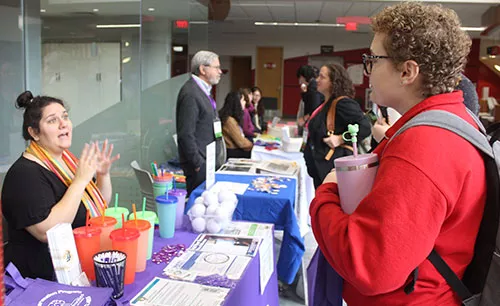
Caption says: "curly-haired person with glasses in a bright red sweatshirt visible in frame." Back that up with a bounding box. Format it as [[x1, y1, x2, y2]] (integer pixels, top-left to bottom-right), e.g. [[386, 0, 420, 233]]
[[310, 2, 486, 306]]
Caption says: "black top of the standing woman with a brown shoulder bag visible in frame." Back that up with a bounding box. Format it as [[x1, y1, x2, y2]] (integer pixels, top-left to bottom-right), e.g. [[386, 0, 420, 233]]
[[304, 98, 371, 187]]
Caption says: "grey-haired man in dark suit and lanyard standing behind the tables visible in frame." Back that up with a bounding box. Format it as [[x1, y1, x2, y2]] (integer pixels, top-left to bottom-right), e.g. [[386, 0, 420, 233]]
[[176, 51, 222, 194]]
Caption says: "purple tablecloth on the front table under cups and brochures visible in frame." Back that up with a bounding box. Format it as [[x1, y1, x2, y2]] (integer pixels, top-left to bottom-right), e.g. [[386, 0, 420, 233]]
[[117, 230, 279, 306]]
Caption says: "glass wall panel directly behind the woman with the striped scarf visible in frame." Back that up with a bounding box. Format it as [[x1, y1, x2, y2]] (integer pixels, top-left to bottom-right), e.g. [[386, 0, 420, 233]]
[[29, 0, 141, 207]]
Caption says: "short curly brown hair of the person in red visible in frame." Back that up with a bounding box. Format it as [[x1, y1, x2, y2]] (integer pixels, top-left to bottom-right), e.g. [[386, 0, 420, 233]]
[[372, 2, 472, 97]]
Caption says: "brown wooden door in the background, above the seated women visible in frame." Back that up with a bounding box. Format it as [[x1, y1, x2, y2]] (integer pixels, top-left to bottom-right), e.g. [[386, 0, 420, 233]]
[[255, 47, 283, 113]]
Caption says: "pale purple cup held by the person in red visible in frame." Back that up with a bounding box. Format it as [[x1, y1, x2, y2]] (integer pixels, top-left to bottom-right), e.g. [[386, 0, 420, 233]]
[[334, 153, 378, 215]]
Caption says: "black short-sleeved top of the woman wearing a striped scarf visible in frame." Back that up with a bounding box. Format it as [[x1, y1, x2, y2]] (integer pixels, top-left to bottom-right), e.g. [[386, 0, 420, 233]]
[[2, 156, 86, 280]]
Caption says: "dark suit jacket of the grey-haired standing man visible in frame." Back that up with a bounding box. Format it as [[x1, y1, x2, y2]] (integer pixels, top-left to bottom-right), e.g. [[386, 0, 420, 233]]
[[176, 77, 225, 175]]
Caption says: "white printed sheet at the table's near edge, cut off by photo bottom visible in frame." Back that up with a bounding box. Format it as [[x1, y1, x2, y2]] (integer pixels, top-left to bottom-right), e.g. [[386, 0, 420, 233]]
[[130, 277, 229, 306]]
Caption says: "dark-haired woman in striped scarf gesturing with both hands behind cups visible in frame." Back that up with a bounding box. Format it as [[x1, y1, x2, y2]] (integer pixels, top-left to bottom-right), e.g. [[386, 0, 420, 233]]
[[2, 91, 120, 280]]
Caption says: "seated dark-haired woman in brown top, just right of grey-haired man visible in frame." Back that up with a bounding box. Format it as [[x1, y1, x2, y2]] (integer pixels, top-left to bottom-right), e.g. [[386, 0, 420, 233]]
[[219, 92, 253, 158]]
